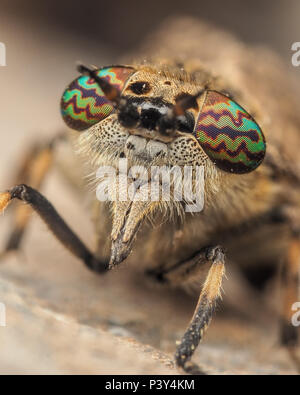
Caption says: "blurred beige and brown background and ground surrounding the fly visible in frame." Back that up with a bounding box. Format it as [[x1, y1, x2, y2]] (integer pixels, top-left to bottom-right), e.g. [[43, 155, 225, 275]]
[[0, 0, 300, 373]]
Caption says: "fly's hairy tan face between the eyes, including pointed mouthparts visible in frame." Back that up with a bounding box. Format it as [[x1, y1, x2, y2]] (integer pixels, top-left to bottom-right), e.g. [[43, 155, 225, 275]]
[[72, 67, 211, 265]]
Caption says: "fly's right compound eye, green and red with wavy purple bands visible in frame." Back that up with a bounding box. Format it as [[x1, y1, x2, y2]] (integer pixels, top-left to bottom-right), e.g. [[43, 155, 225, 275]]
[[194, 91, 266, 174]]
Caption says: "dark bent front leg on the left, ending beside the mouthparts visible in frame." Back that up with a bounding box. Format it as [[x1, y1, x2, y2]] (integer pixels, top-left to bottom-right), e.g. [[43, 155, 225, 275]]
[[0, 184, 108, 273]]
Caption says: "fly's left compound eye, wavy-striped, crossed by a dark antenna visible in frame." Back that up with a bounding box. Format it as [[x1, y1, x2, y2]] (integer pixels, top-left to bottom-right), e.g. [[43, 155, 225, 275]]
[[60, 66, 135, 131]]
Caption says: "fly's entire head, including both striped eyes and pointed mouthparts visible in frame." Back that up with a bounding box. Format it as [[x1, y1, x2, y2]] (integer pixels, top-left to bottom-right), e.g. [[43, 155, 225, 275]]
[[69, 66, 265, 265]]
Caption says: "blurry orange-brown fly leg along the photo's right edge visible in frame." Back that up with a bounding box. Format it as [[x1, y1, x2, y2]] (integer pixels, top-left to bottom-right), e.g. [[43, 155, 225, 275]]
[[280, 237, 300, 371]]
